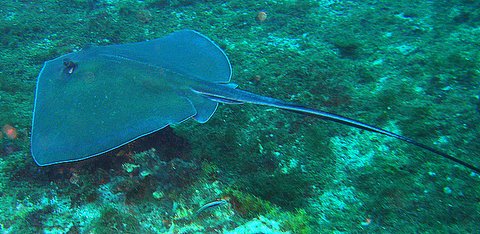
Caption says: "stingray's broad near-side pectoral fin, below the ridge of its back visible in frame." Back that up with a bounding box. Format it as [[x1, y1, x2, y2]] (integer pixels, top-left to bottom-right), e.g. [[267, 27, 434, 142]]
[[31, 51, 197, 166]]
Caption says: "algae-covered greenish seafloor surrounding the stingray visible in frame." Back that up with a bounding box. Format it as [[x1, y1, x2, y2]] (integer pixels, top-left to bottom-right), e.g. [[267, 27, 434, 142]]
[[0, 0, 480, 233]]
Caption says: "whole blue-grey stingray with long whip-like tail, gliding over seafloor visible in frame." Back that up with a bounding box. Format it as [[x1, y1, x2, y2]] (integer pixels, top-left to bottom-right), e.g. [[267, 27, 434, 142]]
[[31, 30, 480, 172]]
